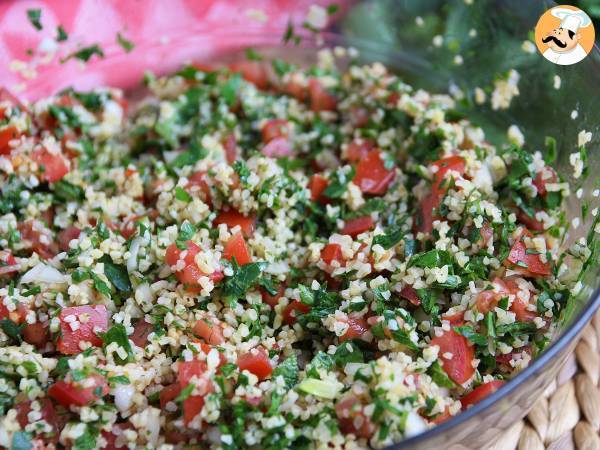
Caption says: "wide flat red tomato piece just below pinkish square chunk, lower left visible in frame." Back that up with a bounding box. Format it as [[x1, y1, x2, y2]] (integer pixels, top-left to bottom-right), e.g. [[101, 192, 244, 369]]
[[48, 374, 109, 408]]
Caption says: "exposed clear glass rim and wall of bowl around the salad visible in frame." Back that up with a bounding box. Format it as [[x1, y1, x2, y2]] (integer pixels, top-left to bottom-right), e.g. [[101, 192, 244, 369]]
[[5, 0, 600, 450]]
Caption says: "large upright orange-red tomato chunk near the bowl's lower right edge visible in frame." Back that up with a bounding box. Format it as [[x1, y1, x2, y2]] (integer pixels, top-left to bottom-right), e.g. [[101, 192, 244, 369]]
[[431, 330, 475, 384]]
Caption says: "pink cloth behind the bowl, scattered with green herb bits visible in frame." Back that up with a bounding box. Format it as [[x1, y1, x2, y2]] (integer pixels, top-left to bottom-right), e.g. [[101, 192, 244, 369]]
[[0, 0, 333, 100]]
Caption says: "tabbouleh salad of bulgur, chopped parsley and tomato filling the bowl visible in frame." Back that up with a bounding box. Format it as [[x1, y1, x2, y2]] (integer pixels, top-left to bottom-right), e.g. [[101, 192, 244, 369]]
[[0, 49, 591, 450]]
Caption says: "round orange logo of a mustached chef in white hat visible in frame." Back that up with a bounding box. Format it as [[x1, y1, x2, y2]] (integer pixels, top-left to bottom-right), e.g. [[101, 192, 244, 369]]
[[535, 5, 595, 66]]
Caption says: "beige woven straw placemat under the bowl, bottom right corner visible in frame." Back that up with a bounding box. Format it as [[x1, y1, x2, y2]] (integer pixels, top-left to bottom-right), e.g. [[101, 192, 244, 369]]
[[488, 312, 600, 450]]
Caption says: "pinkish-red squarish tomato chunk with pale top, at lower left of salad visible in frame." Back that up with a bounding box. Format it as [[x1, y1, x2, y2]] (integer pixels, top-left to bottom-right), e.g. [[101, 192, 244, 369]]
[[57, 305, 108, 355]]
